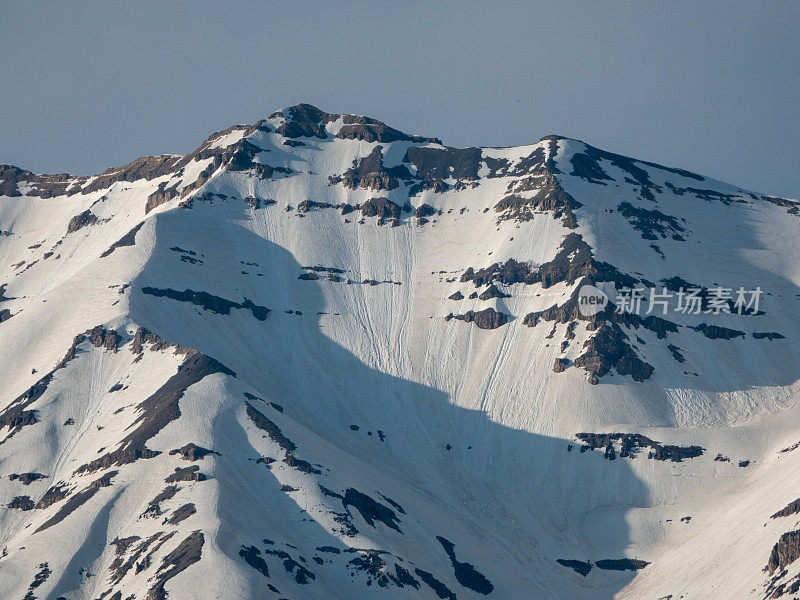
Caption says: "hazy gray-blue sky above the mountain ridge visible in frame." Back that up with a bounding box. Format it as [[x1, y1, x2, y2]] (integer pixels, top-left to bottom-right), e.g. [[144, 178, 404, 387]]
[[0, 0, 800, 197]]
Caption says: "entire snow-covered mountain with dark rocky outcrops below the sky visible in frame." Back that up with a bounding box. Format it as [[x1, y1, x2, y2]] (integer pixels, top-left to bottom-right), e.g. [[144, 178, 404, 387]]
[[0, 105, 800, 600]]
